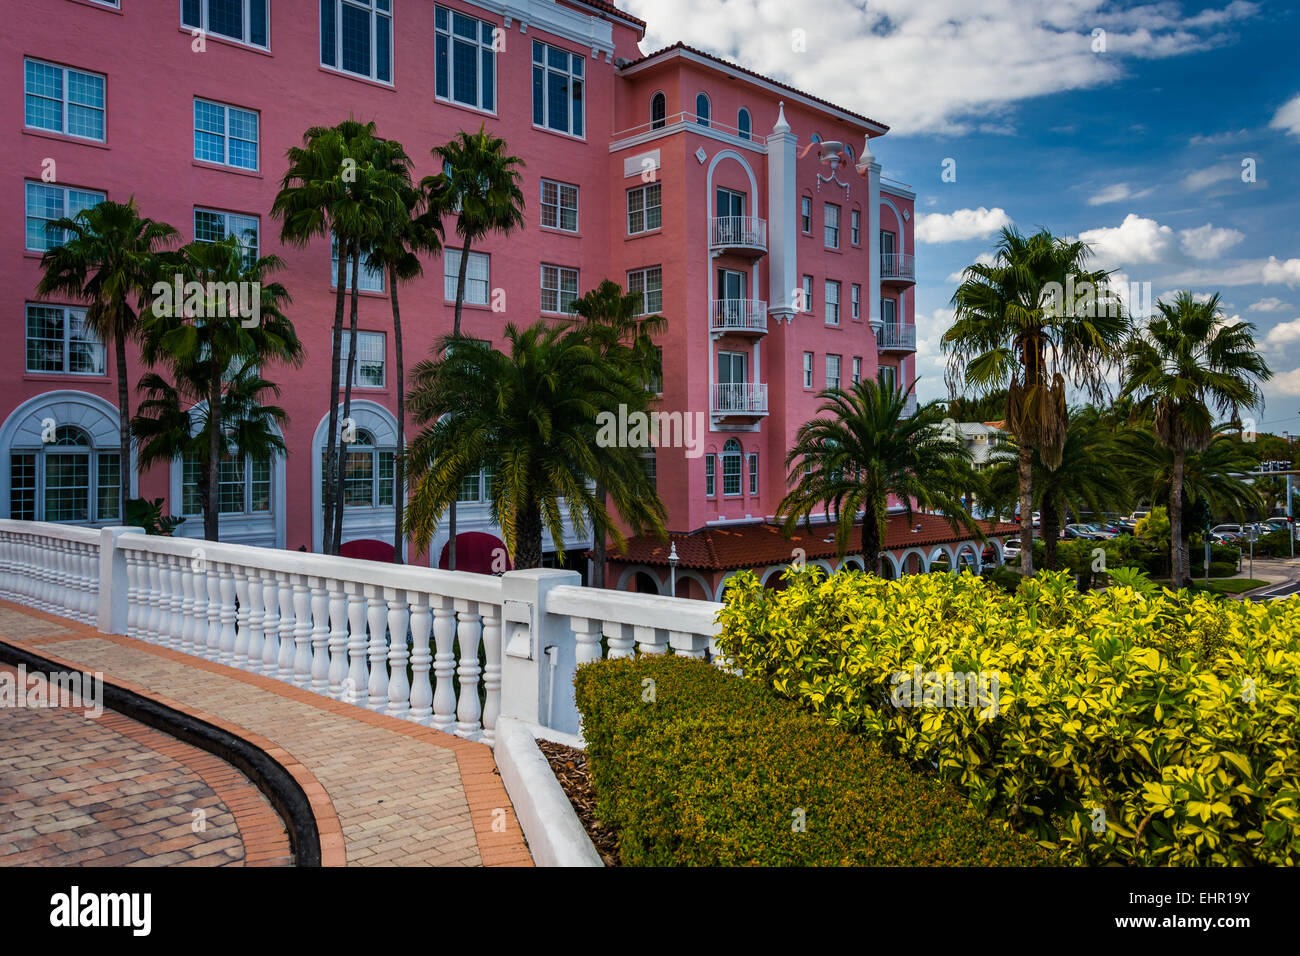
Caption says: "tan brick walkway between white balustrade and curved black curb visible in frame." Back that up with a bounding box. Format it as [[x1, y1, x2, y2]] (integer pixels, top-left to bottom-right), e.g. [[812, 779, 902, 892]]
[[0, 601, 532, 866]]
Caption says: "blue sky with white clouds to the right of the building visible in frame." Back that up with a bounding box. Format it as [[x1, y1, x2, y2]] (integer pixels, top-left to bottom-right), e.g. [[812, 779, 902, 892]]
[[619, 0, 1300, 434]]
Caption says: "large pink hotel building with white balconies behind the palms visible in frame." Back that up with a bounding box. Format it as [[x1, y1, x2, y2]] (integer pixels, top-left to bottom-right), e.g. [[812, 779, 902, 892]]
[[0, 0, 941, 597]]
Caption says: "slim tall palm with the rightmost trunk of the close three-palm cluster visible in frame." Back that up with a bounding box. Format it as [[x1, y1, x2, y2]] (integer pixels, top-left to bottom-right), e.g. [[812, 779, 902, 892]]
[[371, 140, 442, 563]]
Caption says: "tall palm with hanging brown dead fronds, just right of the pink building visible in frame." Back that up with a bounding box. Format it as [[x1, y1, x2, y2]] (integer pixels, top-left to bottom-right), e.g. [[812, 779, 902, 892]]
[[943, 226, 1127, 575]]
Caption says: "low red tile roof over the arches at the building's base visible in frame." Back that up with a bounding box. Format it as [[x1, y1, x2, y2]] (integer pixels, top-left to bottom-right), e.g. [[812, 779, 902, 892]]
[[610, 514, 1021, 571]]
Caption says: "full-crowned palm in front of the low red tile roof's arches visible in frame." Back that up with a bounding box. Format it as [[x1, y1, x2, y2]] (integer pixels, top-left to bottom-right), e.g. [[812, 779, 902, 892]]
[[777, 378, 983, 574]]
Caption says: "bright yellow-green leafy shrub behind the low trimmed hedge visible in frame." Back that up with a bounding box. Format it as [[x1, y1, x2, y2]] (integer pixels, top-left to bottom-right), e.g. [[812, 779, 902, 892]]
[[718, 568, 1300, 865]]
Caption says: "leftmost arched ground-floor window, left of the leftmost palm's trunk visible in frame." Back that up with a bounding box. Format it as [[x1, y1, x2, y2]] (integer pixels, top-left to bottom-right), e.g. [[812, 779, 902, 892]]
[[9, 425, 122, 524]]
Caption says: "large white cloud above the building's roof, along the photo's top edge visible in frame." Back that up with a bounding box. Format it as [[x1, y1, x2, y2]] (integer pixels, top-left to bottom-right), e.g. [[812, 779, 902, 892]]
[[620, 0, 1257, 138]]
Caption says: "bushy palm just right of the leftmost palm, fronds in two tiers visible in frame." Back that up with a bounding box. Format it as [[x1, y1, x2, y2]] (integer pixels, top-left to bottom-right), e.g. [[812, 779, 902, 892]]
[[133, 235, 303, 541]]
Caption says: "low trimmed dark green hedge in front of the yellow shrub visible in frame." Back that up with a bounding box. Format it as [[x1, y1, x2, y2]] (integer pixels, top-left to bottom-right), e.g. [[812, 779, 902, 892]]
[[575, 657, 1050, 866]]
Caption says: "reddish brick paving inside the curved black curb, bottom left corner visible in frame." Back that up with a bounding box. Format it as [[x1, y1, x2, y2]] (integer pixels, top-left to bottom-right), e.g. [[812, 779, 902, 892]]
[[0, 665, 293, 866]]
